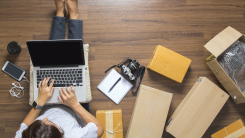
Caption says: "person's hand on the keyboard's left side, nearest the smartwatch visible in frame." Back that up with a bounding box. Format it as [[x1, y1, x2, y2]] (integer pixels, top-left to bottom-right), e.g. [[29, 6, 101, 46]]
[[37, 78, 54, 106]]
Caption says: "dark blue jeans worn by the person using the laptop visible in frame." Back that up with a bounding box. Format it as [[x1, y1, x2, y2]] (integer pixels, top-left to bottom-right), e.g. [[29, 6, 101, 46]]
[[50, 16, 90, 112]]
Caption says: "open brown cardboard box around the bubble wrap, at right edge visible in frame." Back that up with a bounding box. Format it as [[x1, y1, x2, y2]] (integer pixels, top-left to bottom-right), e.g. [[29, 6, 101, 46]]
[[204, 26, 245, 104]]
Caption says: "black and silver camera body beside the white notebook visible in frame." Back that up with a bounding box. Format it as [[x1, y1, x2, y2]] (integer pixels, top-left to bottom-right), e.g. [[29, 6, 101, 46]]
[[121, 60, 140, 81]]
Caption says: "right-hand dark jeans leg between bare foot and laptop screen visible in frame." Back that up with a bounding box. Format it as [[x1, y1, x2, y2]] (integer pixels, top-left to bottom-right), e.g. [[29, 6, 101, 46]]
[[68, 19, 83, 39]]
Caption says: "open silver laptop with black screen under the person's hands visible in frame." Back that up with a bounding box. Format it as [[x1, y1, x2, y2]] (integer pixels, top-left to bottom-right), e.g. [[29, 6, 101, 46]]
[[26, 39, 87, 103]]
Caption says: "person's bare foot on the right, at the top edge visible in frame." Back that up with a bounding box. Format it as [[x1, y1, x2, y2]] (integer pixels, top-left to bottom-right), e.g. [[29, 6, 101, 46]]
[[65, 0, 78, 19]]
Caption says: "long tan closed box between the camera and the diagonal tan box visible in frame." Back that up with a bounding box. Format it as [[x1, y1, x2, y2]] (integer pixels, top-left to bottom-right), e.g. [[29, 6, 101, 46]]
[[126, 84, 173, 138]]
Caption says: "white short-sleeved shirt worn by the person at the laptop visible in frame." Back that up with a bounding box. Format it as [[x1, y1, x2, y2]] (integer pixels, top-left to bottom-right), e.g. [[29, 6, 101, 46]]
[[15, 108, 98, 138]]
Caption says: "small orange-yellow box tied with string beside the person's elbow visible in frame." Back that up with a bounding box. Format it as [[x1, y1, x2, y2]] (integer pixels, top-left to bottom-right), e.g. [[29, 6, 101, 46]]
[[96, 109, 123, 138]]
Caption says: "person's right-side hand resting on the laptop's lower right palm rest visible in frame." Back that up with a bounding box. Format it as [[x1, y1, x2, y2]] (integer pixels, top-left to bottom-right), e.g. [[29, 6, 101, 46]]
[[58, 86, 80, 108]]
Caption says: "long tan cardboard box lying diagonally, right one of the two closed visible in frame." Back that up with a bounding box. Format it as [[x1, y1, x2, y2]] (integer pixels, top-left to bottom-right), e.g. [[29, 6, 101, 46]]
[[166, 77, 229, 138]]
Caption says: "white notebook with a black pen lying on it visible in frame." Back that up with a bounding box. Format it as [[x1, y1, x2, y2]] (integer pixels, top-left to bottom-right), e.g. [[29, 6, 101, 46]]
[[97, 69, 133, 104]]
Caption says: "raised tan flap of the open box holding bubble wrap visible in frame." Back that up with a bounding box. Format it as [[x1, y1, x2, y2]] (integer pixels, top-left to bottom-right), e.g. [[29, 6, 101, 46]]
[[204, 26, 242, 57]]
